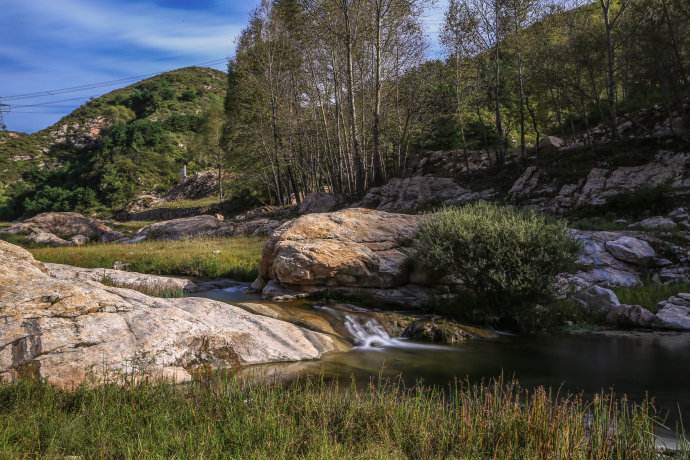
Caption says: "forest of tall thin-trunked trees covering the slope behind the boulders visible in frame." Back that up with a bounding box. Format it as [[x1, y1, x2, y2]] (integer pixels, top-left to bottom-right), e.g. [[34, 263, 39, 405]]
[[218, 0, 690, 204]]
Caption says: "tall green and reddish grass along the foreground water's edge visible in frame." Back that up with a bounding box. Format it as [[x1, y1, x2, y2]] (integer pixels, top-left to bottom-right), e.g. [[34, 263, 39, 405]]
[[0, 377, 685, 460]]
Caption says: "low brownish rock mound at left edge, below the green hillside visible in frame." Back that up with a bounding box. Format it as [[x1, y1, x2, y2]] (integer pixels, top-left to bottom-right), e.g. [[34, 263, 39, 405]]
[[4, 212, 122, 246]]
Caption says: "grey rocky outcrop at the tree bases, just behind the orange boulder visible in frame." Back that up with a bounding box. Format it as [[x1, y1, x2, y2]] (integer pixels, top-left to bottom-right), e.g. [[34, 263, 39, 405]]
[[358, 176, 495, 213]]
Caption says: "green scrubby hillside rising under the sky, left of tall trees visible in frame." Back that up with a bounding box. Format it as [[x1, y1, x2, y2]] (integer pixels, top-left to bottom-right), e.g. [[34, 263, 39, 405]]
[[0, 67, 225, 215]]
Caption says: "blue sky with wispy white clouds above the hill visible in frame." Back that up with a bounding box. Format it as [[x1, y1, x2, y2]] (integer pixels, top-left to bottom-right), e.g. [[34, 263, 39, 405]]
[[0, 0, 445, 132]]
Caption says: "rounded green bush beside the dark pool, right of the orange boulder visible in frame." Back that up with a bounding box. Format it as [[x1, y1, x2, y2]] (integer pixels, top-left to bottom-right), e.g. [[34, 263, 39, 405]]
[[415, 203, 577, 324]]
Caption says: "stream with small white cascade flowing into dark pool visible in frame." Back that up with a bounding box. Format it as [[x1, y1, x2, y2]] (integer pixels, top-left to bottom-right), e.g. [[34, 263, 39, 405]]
[[198, 287, 690, 442]]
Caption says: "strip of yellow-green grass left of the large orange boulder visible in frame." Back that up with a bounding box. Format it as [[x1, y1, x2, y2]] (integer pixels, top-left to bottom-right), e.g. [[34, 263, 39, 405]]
[[30, 238, 263, 281]]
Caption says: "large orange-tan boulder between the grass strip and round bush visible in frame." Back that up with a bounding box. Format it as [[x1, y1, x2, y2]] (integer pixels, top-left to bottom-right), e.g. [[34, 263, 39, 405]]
[[255, 209, 432, 305]]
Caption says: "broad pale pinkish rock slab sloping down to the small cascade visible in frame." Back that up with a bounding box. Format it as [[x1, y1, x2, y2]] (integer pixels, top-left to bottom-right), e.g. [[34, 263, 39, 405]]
[[0, 241, 344, 388]]
